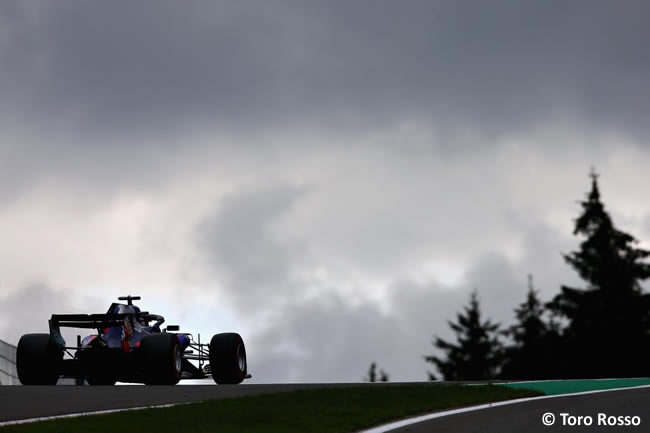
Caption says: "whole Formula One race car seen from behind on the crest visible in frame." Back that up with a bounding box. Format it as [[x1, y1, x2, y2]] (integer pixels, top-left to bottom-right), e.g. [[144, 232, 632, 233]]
[[16, 295, 251, 385]]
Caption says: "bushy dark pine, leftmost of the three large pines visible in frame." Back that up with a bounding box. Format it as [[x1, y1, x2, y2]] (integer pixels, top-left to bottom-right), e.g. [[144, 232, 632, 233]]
[[424, 291, 501, 380]]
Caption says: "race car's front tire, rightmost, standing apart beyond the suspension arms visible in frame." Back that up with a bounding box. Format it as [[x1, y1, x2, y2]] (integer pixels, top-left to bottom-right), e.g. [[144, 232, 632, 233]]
[[210, 332, 248, 385]]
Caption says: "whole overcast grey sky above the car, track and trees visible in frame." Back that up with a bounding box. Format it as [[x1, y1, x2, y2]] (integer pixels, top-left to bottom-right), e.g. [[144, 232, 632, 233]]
[[0, 0, 650, 382]]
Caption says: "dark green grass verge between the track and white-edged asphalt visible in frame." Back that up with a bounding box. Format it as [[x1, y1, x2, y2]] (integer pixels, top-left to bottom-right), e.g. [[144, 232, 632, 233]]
[[0, 384, 541, 433]]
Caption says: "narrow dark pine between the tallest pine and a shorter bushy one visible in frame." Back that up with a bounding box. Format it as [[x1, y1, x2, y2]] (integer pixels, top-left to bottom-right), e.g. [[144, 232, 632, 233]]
[[500, 275, 556, 379]]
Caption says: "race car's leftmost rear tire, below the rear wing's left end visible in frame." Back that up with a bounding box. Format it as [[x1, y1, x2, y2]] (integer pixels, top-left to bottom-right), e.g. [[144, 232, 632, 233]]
[[16, 334, 63, 385]]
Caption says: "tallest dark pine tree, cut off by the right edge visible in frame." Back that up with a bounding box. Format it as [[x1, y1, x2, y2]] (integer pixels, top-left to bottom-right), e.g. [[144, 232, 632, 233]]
[[549, 170, 650, 377]]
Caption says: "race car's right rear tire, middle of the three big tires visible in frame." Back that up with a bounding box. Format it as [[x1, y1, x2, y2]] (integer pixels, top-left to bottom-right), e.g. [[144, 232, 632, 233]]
[[140, 333, 183, 385]]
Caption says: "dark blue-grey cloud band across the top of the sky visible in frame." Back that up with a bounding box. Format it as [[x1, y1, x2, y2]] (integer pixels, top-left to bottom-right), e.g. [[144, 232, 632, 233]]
[[5, 1, 650, 135]]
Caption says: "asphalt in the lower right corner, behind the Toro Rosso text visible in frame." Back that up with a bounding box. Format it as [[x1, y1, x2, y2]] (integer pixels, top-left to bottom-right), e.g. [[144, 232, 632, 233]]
[[391, 388, 650, 433]]
